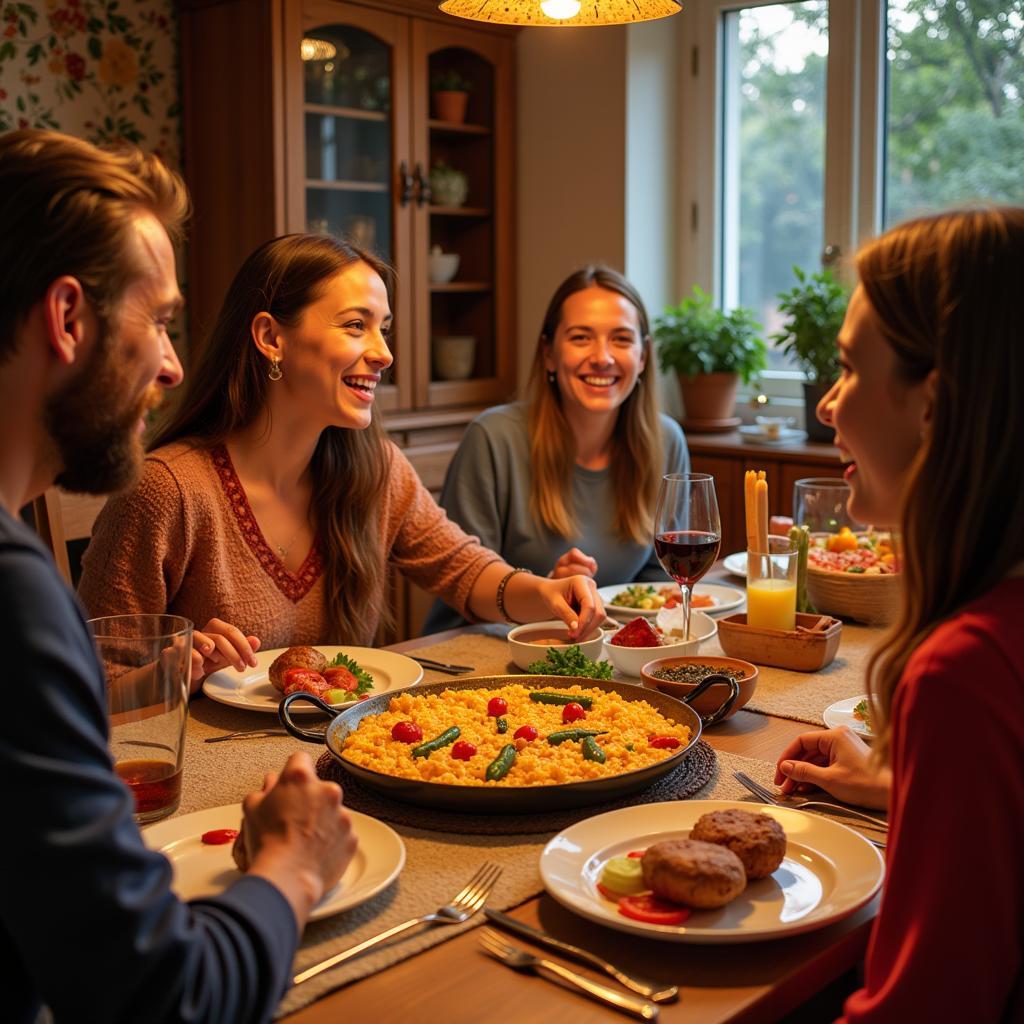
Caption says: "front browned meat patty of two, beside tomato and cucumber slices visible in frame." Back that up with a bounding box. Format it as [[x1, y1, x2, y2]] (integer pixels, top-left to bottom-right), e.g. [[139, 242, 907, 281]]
[[640, 839, 746, 910]]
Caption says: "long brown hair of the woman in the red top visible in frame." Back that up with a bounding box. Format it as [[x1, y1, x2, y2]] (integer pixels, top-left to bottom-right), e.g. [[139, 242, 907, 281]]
[[857, 207, 1024, 760]]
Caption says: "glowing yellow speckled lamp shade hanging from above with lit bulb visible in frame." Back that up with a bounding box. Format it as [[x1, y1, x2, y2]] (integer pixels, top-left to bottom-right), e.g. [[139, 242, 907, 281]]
[[440, 0, 680, 28]]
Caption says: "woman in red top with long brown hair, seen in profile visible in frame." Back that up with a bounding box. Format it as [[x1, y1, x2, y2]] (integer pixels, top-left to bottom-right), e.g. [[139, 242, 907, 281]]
[[775, 208, 1024, 1024]]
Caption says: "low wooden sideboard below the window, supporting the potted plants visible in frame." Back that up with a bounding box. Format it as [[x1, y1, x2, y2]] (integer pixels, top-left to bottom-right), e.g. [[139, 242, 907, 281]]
[[686, 433, 843, 555]]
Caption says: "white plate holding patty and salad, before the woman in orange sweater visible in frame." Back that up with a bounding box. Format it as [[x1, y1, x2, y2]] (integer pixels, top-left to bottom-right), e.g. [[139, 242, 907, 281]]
[[203, 644, 423, 715]]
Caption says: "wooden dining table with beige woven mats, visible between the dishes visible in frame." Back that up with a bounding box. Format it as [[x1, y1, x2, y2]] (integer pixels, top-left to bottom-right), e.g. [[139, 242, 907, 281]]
[[167, 568, 881, 1024]]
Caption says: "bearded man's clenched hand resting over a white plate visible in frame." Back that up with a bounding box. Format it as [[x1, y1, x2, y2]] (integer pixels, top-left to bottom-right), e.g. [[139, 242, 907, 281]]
[[242, 753, 358, 930]]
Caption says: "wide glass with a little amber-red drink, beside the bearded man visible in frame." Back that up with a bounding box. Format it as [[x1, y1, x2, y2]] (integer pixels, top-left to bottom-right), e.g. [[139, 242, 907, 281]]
[[89, 614, 193, 823]]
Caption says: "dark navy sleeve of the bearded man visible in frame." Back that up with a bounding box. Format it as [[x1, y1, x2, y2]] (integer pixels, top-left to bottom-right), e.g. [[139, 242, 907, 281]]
[[0, 511, 297, 1024]]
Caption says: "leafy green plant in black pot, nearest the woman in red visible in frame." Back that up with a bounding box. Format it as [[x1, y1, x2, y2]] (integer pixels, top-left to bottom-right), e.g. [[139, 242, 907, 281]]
[[771, 266, 850, 441]]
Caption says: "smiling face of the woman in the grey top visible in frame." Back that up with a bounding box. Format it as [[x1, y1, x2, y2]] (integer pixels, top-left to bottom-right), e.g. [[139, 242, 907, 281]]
[[544, 287, 647, 415]]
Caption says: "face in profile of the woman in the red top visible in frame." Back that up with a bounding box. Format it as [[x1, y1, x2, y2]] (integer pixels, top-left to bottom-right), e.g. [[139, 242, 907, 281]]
[[817, 287, 931, 526]]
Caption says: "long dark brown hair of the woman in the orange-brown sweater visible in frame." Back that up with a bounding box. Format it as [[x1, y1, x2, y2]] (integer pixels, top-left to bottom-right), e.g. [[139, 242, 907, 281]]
[[151, 234, 393, 642]]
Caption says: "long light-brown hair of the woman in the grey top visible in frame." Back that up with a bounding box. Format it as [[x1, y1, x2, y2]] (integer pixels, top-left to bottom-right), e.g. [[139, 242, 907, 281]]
[[527, 265, 665, 544]]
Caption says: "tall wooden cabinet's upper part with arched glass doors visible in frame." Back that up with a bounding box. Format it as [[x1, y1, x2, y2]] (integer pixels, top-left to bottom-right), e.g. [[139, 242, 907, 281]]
[[181, 0, 515, 414]]
